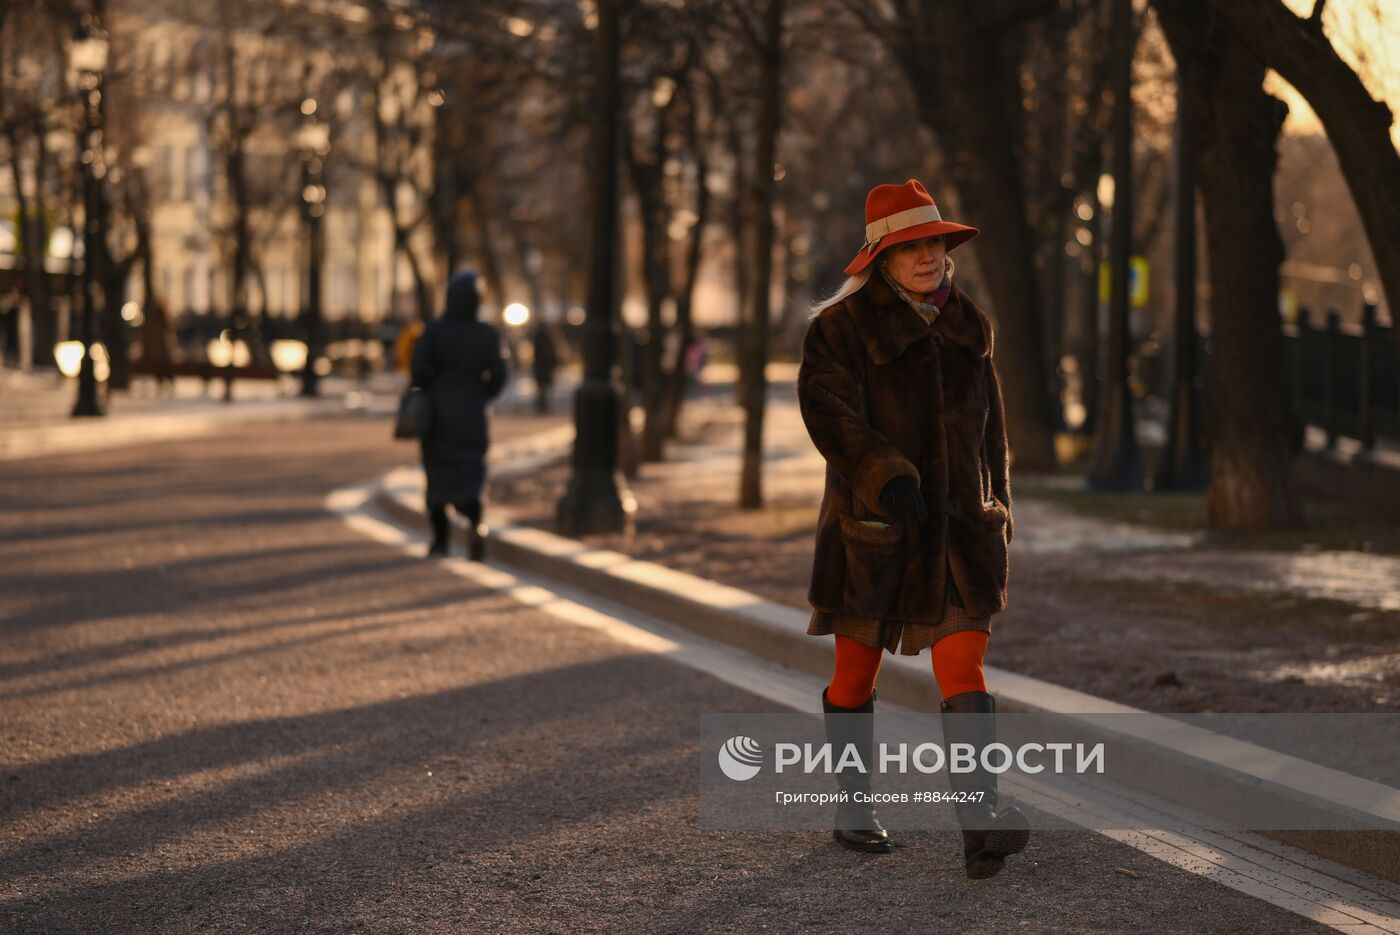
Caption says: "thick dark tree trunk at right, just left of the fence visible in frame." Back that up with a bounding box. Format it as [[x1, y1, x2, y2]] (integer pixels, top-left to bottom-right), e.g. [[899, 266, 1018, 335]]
[[1156, 0, 1302, 529]]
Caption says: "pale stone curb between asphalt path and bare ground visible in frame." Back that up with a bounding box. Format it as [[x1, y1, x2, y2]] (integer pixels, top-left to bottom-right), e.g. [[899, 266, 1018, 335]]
[[374, 470, 1400, 882]]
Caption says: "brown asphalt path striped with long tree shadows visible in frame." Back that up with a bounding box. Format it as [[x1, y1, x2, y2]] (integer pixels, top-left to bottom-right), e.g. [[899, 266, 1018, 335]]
[[0, 417, 1324, 932]]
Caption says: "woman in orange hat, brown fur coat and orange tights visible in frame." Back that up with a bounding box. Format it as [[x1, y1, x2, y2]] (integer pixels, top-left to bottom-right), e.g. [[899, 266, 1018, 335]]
[[798, 179, 1029, 879]]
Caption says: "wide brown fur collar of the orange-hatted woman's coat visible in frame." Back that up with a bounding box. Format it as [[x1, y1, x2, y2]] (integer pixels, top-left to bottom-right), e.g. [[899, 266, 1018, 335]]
[[846, 276, 993, 364]]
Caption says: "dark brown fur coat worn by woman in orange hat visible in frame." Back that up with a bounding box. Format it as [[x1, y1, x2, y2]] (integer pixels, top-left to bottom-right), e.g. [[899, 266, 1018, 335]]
[[798, 276, 1014, 623]]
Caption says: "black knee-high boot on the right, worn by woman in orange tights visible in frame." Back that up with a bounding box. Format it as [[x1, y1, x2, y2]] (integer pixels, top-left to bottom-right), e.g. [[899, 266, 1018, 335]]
[[942, 691, 1030, 880]]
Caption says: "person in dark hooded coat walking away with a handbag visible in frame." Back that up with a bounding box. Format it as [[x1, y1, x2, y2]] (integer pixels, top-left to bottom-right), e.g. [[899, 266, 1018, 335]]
[[413, 273, 507, 561]]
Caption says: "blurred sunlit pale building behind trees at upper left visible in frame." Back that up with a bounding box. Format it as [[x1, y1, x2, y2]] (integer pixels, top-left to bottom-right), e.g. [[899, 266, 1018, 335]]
[[0, 0, 441, 361]]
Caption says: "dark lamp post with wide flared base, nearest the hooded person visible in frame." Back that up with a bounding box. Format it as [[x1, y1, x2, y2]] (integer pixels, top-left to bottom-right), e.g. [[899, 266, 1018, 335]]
[[556, 0, 636, 536]]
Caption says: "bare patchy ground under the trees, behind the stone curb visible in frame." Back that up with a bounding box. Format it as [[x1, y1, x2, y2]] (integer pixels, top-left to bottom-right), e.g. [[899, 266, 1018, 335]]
[[493, 406, 1400, 712]]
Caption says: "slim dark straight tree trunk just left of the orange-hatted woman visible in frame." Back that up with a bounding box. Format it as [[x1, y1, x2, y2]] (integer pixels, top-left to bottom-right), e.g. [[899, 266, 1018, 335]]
[[739, 0, 783, 509]]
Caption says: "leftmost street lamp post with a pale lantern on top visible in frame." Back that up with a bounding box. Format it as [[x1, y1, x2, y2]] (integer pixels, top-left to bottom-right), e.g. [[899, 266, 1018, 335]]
[[70, 18, 108, 417]]
